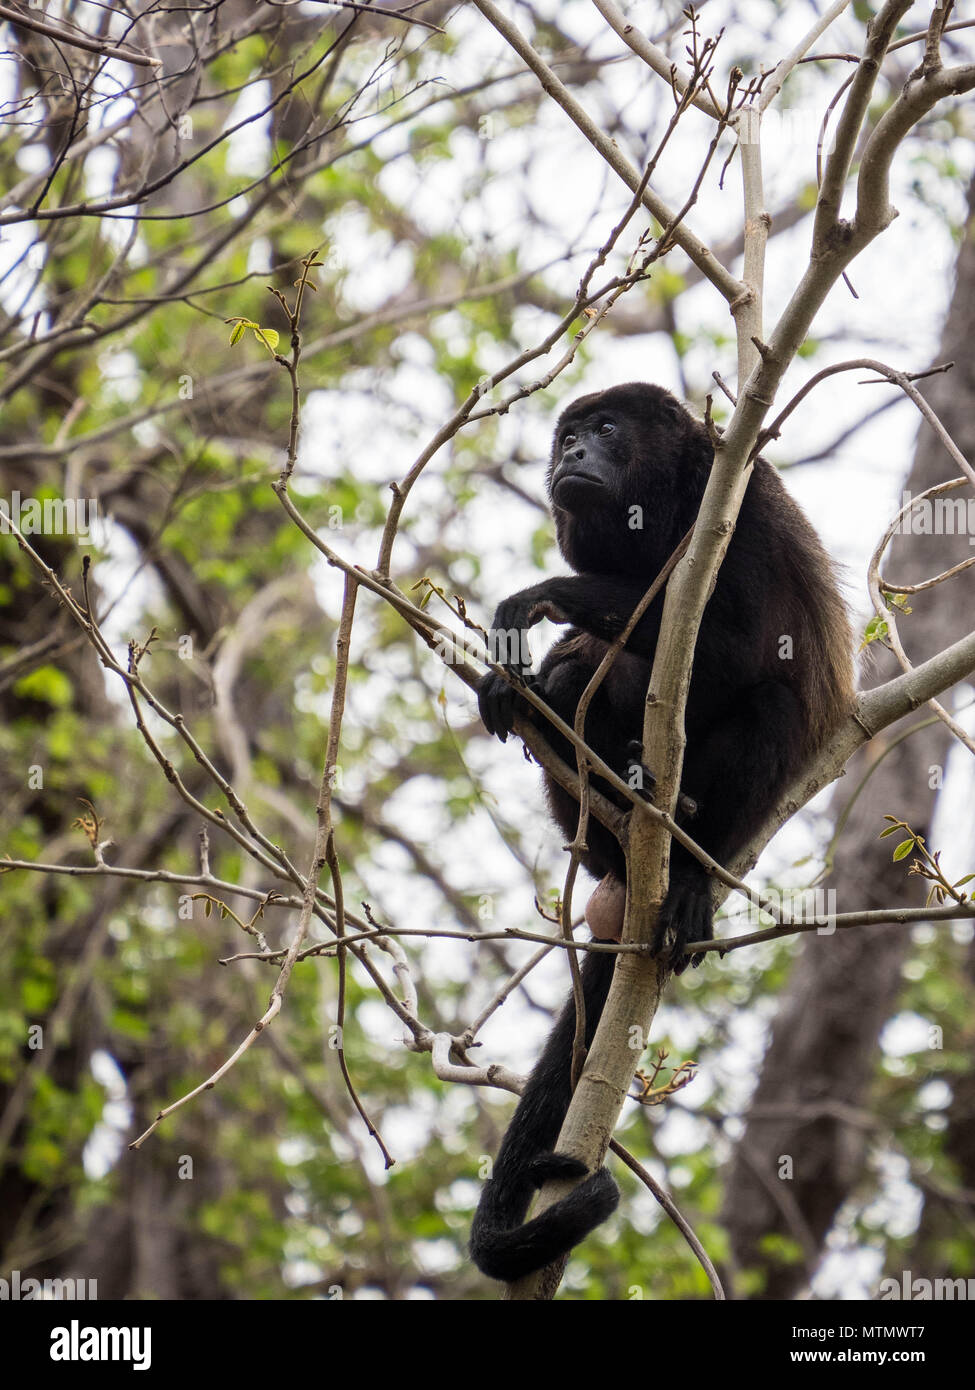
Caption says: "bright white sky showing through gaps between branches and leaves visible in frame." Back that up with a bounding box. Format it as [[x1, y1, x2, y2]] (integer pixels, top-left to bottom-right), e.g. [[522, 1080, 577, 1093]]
[[7, 0, 975, 1297]]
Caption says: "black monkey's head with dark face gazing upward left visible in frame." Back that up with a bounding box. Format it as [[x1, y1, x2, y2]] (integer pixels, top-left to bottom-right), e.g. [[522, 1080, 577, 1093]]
[[548, 382, 712, 574]]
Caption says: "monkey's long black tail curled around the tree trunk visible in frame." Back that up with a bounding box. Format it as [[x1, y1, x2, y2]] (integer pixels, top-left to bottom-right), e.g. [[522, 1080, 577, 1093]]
[[470, 952, 619, 1283]]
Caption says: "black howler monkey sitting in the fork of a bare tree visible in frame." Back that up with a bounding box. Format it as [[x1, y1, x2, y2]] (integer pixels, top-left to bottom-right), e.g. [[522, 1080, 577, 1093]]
[[470, 382, 853, 1280]]
